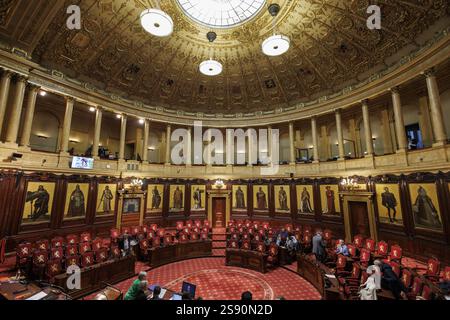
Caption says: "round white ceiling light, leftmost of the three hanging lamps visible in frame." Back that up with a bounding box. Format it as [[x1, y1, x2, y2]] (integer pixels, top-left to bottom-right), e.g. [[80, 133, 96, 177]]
[[141, 9, 173, 37]]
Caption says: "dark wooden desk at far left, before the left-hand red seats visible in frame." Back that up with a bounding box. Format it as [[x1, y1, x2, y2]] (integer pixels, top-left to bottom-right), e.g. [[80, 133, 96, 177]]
[[54, 255, 136, 299]]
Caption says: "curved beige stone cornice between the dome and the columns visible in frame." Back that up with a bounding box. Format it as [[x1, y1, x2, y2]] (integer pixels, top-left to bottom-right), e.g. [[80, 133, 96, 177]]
[[0, 30, 450, 127]]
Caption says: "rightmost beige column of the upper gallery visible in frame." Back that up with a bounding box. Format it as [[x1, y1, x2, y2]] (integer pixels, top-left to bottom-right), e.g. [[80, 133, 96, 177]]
[[425, 69, 447, 145]]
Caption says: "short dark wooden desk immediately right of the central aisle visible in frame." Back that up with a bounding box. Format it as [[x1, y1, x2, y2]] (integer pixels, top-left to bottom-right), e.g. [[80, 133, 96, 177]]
[[225, 248, 267, 273]]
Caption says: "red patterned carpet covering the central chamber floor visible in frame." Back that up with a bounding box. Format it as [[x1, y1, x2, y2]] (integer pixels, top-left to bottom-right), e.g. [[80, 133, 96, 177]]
[[86, 258, 321, 300]]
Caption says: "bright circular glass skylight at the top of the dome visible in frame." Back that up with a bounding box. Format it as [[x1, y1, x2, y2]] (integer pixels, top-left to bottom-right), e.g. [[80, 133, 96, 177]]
[[177, 0, 266, 28]]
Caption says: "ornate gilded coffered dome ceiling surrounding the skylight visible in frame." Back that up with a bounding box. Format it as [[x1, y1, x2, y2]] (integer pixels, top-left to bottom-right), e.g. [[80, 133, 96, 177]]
[[33, 0, 450, 114]]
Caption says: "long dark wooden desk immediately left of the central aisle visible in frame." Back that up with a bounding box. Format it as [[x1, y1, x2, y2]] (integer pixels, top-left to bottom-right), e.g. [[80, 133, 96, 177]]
[[148, 240, 212, 268]]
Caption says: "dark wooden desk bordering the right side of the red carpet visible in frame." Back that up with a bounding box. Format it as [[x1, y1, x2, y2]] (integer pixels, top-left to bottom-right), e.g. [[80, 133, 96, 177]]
[[297, 254, 341, 300]]
